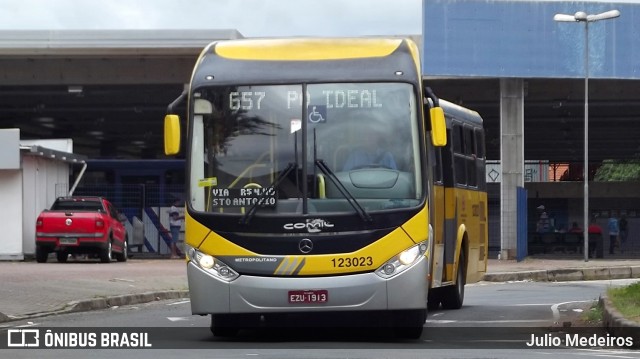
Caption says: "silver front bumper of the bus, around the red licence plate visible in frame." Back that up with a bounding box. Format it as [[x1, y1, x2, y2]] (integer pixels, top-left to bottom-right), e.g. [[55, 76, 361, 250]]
[[187, 257, 429, 315]]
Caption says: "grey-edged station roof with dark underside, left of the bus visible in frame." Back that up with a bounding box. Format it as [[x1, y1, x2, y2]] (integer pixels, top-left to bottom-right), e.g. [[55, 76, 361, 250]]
[[0, 30, 242, 158]]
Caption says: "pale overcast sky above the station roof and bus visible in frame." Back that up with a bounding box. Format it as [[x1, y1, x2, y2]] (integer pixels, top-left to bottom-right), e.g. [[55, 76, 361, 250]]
[[0, 0, 422, 37]]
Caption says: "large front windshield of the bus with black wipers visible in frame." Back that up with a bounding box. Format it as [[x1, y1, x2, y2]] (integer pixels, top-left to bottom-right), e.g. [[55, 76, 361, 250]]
[[190, 82, 425, 214]]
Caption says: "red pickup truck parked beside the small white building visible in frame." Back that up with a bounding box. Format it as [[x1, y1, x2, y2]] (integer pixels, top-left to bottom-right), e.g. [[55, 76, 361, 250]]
[[36, 197, 127, 263]]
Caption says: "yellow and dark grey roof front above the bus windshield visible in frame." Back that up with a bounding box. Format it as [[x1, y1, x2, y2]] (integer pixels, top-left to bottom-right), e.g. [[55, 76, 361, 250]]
[[191, 38, 420, 89]]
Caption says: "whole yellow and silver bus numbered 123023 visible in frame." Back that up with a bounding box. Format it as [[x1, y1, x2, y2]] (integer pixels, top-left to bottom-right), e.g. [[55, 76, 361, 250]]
[[164, 38, 487, 338]]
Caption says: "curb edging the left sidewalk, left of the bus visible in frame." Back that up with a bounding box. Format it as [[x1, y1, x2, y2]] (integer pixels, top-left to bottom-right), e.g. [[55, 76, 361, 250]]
[[0, 290, 189, 323]]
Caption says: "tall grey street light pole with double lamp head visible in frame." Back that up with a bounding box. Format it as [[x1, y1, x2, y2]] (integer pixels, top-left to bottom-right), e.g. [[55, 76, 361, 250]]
[[553, 10, 620, 262]]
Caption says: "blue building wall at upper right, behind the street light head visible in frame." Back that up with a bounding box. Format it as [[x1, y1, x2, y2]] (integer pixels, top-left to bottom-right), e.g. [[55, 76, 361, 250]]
[[422, 0, 640, 79]]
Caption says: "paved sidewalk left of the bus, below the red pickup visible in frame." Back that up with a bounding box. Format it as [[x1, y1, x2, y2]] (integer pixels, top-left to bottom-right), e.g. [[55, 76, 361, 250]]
[[0, 259, 188, 322]]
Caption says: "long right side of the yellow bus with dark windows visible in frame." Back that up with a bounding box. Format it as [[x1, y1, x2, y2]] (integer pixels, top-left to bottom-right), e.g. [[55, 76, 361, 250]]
[[428, 100, 488, 309]]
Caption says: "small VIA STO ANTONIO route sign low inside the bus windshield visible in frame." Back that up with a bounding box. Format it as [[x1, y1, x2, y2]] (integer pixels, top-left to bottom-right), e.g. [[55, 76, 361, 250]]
[[210, 188, 277, 207]]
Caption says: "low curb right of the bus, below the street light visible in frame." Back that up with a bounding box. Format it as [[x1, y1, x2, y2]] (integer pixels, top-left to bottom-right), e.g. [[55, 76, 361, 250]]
[[482, 266, 640, 282]]
